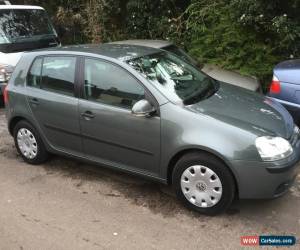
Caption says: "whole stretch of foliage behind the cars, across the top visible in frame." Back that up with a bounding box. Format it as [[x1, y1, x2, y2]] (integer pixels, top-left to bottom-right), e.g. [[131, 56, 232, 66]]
[[9, 0, 300, 88]]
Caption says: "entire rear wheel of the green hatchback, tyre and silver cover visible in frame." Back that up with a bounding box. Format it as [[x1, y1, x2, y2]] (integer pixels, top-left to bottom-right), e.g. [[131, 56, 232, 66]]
[[13, 120, 49, 165]]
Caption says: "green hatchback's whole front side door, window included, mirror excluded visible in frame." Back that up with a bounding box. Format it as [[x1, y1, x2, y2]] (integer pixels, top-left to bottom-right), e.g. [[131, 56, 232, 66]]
[[79, 58, 160, 175]]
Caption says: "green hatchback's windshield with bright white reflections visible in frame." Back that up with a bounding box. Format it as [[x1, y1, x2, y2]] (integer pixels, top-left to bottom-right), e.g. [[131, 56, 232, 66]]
[[127, 52, 217, 105]]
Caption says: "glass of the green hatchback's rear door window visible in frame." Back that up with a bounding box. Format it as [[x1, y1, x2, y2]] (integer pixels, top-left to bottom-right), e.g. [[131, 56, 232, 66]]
[[27, 56, 76, 96]]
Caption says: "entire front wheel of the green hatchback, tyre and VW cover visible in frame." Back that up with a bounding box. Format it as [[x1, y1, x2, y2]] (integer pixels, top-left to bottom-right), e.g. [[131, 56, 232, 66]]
[[172, 152, 236, 215]]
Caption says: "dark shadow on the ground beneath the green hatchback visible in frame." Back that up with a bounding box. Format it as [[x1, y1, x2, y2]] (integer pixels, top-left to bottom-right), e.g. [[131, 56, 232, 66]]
[[38, 153, 299, 219]]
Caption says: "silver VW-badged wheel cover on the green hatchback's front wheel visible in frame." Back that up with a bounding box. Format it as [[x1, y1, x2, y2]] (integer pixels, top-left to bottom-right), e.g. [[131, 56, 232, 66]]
[[180, 165, 222, 208]]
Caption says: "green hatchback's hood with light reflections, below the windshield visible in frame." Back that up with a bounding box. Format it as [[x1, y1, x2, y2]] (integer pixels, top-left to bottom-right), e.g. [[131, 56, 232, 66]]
[[188, 83, 294, 139]]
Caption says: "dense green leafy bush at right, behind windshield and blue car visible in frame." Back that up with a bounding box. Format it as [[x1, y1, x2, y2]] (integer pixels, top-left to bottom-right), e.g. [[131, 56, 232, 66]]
[[175, 0, 300, 88]]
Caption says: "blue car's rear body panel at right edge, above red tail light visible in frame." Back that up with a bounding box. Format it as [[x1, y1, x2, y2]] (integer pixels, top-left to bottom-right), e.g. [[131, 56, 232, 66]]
[[274, 59, 300, 84]]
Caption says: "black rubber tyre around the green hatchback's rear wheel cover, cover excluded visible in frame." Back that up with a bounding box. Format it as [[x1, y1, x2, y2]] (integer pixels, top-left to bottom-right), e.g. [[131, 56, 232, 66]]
[[13, 121, 48, 165]]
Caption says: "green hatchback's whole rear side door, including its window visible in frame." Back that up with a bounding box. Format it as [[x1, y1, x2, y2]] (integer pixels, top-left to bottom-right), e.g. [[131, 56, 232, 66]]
[[26, 56, 82, 154]]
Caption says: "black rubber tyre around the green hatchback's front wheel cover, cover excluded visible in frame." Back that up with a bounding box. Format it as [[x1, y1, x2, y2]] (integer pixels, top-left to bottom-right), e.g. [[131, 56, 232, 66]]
[[172, 153, 235, 215]]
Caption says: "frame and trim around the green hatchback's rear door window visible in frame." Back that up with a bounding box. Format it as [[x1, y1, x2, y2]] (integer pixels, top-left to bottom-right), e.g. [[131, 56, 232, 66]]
[[25, 54, 80, 98]]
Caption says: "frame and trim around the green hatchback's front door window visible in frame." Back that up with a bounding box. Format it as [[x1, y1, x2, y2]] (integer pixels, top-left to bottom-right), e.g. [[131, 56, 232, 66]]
[[79, 56, 160, 116]]
